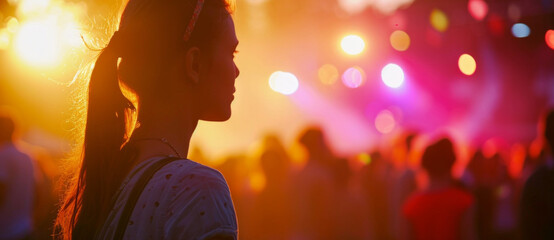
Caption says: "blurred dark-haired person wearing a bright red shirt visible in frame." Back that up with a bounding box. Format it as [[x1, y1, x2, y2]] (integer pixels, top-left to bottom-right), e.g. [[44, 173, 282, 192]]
[[402, 138, 475, 240]]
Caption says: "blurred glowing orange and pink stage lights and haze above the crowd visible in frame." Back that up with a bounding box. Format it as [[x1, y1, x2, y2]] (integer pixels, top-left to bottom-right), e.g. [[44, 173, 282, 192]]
[[0, 0, 554, 239]]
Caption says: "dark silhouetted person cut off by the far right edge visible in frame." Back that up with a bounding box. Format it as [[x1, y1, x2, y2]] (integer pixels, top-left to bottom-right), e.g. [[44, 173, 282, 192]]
[[520, 111, 554, 239]]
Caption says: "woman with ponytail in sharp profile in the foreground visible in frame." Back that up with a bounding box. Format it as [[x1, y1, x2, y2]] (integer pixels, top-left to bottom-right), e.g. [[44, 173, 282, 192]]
[[56, 0, 239, 239]]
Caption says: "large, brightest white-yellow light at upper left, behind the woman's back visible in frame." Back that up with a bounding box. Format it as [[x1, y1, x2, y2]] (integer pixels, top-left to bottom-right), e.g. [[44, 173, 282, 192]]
[[15, 21, 60, 66]]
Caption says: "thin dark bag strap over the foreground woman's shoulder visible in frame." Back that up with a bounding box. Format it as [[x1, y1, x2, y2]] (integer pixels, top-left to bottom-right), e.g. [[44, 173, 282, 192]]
[[113, 157, 181, 240]]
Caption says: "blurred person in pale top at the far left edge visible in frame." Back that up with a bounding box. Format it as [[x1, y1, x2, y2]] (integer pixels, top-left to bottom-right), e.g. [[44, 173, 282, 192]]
[[0, 113, 35, 240]]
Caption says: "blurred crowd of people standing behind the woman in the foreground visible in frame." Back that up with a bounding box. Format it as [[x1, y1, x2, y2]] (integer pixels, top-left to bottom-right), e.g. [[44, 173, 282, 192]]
[[0, 107, 554, 240]]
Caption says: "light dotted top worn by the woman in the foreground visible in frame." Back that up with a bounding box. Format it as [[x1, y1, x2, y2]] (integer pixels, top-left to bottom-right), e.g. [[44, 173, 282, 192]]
[[96, 157, 238, 240]]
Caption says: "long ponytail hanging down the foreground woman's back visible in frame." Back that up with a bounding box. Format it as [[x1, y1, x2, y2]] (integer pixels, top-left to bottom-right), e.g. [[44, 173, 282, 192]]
[[55, 40, 134, 239]]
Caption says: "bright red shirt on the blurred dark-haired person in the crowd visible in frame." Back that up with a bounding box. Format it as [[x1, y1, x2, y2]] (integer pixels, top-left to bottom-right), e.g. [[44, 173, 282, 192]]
[[403, 187, 473, 240]]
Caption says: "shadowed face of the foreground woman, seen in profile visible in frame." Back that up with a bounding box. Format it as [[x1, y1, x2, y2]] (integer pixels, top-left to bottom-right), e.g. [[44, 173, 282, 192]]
[[197, 16, 239, 121]]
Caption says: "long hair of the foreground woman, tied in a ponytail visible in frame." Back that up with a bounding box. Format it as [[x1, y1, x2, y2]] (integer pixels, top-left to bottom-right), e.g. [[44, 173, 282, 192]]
[[54, 0, 232, 239]]
